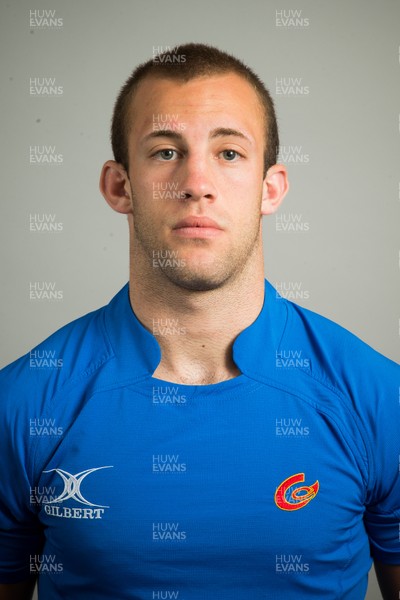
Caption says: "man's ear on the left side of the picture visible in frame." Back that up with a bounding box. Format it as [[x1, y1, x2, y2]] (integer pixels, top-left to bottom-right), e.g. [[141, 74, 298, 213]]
[[99, 160, 132, 215]]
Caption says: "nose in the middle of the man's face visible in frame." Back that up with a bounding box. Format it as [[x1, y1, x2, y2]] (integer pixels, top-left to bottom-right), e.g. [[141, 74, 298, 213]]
[[180, 154, 217, 202]]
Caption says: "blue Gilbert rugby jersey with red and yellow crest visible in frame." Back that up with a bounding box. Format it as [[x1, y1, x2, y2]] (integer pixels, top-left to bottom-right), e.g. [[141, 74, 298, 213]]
[[0, 282, 400, 600]]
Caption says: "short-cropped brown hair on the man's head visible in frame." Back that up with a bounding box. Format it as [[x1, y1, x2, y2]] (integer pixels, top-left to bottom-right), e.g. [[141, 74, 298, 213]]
[[111, 43, 279, 174]]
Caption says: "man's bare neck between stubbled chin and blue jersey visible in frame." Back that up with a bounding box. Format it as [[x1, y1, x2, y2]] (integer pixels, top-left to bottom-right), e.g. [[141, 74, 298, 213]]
[[129, 255, 264, 385]]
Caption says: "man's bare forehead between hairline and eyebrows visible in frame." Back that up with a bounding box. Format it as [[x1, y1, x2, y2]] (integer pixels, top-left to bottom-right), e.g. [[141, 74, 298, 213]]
[[128, 72, 264, 135]]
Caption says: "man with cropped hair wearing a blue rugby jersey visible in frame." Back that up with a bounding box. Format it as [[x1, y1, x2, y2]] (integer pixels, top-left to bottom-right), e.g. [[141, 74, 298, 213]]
[[0, 44, 400, 600]]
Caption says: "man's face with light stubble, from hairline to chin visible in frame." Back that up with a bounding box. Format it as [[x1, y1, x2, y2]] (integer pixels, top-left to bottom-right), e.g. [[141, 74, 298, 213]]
[[128, 73, 265, 290]]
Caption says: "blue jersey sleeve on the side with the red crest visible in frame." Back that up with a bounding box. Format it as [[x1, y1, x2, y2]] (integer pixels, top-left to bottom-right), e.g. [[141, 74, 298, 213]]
[[289, 305, 400, 564]]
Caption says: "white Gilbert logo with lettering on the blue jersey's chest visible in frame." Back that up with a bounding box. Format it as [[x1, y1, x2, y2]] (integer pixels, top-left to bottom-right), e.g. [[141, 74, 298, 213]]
[[43, 465, 112, 519]]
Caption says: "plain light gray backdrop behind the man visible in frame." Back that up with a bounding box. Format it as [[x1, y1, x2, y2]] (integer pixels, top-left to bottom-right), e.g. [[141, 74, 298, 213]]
[[0, 0, 400, 599]]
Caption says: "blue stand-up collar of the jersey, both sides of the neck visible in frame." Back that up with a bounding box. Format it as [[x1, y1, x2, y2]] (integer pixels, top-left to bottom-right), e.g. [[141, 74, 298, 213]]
[[105, 280, 287, 377]]
